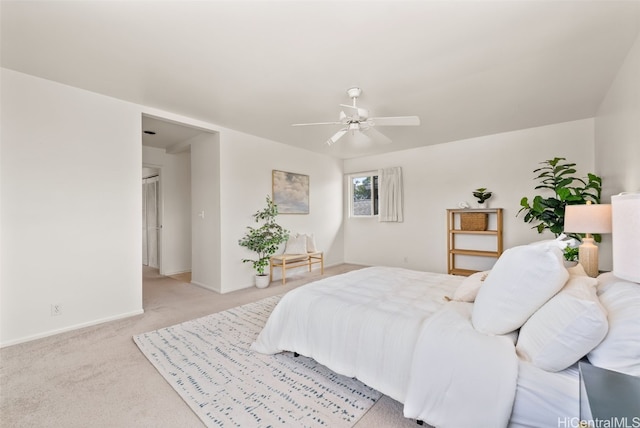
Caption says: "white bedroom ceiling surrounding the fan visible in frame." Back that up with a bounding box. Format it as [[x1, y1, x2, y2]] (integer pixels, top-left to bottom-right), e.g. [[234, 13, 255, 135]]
[[1, 0, 640, 158]]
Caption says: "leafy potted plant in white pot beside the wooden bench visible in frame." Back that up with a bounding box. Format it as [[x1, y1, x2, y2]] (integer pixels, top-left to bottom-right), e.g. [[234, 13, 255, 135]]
[[238, 196, 289, 288]]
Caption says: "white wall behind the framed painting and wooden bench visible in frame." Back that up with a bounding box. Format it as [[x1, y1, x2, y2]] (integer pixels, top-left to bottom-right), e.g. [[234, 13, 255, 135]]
[[220, 131, 344, 292]]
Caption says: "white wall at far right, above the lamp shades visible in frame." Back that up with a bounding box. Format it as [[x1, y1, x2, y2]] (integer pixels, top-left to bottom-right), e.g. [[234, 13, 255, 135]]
[[595, 30, 640, 196]]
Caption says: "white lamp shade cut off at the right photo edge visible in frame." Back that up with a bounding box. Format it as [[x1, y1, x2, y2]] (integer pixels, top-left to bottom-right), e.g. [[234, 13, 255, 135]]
[[611, 193, 640, 282]]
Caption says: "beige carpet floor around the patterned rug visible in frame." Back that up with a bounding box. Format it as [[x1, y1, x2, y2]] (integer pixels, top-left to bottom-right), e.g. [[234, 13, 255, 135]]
[[0, 265, 430, 428]]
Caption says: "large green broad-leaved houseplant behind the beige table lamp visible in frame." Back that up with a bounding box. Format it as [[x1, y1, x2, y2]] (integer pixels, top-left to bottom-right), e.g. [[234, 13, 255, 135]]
[[517, 157, 602, 256]]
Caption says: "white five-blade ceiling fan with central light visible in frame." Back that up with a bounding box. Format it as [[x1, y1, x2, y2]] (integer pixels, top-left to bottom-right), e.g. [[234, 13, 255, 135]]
[[291, 88, 420, 145]]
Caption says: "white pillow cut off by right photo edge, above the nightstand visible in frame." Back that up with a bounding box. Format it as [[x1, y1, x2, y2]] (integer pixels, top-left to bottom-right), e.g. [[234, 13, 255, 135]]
[[588, 280, 640, 376]]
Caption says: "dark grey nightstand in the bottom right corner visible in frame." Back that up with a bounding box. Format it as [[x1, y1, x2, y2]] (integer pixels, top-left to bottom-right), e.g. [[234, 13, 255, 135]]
[[578, 362, 640, 427]]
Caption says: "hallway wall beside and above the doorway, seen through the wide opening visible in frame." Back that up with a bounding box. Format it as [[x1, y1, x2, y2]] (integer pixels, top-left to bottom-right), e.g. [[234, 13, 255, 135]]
[[142, 147, 191, 275]]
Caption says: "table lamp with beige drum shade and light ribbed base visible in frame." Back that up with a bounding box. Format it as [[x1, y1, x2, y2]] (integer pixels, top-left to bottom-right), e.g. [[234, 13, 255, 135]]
[[564, 201, 611, 278]]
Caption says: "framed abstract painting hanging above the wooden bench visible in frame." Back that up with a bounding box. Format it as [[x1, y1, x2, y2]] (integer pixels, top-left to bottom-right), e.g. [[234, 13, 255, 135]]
[[271, 169, 309, 214]]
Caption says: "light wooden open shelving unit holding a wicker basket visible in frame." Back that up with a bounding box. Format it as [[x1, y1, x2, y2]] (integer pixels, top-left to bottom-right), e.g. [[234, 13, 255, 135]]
[[447, 208, 502, 276]]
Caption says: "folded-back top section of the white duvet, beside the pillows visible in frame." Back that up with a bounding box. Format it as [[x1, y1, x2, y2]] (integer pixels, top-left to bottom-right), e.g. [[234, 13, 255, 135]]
[[404, 302, 518, 428]]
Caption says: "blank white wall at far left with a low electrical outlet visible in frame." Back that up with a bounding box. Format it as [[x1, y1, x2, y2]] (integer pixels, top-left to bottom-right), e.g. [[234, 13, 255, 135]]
[[0, 69, 142, 345]]
